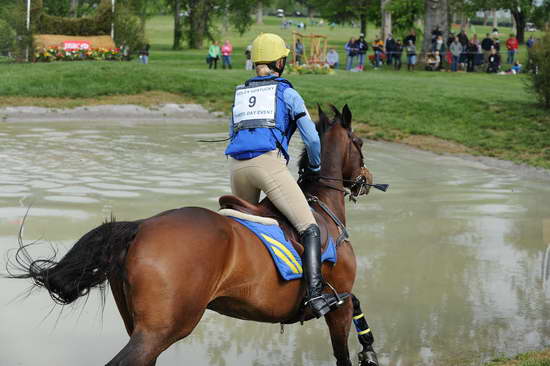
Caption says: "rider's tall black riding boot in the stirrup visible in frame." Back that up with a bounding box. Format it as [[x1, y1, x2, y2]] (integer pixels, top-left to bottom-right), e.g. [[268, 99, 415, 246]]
[[300, 225, 347, 318]]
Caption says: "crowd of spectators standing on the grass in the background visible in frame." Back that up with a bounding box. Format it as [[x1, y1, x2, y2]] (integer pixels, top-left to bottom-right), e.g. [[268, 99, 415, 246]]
[[206, 27, 536, 74]]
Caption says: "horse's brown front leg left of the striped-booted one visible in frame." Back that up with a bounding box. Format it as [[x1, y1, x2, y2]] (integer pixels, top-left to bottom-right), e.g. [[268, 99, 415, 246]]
[[325, 299, 353, 366]]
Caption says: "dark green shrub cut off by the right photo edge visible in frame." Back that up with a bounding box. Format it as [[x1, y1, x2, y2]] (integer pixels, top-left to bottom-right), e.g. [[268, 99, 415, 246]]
[[529, 30, 550, 109]]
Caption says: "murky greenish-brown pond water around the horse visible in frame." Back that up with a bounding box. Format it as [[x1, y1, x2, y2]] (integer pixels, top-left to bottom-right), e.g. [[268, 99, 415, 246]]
[[0, 118, 550, 366]]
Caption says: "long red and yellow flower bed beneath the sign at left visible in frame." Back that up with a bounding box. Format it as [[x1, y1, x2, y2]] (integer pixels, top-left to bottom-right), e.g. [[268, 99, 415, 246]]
[[34, 47, 122, 62]]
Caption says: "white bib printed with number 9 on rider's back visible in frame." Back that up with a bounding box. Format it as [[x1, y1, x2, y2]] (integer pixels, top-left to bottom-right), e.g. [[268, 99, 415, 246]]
[[233, 83, 277, 128]]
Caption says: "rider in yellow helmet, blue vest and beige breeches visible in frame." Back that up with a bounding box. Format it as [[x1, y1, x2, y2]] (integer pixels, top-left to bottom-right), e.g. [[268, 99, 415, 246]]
[[225, 33, 344, 317]]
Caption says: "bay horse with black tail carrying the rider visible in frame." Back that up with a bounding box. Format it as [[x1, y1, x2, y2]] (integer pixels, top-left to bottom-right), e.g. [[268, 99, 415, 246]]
[[9, 105, 386, 366]]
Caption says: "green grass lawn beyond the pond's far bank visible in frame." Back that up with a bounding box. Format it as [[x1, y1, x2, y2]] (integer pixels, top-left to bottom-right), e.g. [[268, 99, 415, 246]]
[[0, 17, 550, 168]]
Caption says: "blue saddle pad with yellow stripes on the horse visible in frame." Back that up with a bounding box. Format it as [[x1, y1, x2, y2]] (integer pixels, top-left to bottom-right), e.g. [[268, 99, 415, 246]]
[[231, 217, 337, 281]]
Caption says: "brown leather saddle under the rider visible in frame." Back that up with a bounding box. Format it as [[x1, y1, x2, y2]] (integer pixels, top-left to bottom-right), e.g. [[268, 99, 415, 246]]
[[219, 195, 329, 256]]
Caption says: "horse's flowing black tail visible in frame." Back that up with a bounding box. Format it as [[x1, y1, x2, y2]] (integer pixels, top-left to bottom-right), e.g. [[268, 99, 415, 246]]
[[8, 220, 141, 305]]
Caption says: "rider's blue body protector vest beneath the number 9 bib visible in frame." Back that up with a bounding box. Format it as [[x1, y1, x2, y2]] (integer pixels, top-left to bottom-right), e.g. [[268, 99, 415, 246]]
[[225, 76, 296, 162]]
